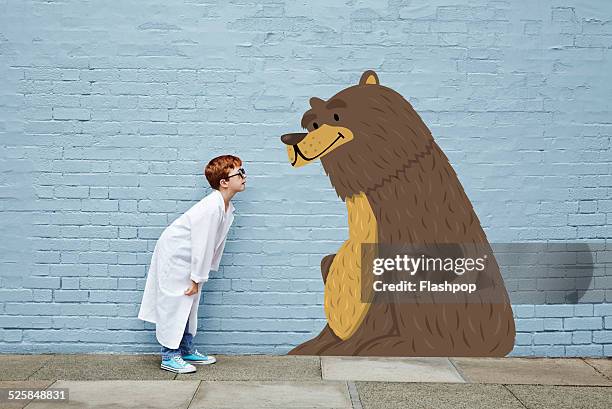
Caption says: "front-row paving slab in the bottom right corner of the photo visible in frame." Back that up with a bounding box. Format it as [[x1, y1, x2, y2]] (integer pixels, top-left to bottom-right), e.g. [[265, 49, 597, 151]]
[[507, 385, 612, 409]]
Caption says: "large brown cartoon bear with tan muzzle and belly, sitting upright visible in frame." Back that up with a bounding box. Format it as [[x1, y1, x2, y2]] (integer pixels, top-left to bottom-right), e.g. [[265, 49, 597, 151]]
[[281, 71, 515, 356]]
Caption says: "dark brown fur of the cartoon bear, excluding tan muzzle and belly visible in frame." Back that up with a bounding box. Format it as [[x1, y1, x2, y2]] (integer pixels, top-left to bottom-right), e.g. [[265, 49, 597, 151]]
[[286, 71, 515, 356]]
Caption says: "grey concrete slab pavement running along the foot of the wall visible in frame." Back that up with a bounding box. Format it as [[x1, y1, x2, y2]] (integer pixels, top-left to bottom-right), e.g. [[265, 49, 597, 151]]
[[0, 354, 612, 409]]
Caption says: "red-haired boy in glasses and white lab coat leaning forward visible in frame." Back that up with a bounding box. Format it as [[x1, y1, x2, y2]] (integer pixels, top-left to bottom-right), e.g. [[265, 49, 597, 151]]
[[138, 155, 246, 373]]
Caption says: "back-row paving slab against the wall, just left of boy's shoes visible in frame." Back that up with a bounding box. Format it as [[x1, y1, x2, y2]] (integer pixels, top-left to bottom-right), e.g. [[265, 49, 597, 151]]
[[29, 354, 176, 381]]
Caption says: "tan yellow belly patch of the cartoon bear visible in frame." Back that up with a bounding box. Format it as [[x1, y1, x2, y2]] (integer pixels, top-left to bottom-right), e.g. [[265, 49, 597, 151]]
[[324, 193, 378, 340]]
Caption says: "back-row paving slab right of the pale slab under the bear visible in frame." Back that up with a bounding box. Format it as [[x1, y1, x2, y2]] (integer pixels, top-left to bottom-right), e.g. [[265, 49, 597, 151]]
[[451, 358, 612, 386]]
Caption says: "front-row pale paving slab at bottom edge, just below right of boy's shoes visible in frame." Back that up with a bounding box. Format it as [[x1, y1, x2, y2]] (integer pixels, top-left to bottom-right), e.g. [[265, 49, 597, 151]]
[[189, 381, 352, 409]]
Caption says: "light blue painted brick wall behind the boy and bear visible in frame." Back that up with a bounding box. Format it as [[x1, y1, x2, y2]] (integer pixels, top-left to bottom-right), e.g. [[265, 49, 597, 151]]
[[0, 0, 612, 356]]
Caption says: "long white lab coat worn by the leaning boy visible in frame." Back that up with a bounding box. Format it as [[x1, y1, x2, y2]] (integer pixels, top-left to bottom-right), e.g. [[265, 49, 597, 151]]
[[138, 189, 234, 349]]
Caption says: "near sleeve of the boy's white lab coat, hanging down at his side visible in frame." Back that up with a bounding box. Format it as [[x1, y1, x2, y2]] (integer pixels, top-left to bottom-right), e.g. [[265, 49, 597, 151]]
[[189, 210, 221, 283]]
